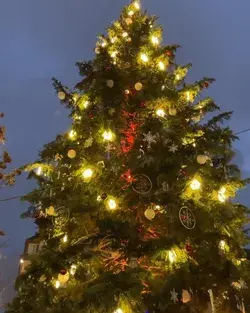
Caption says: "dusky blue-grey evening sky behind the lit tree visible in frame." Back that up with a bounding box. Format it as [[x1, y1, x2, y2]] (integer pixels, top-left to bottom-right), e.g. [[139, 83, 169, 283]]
[[0, 0, 250, 308]]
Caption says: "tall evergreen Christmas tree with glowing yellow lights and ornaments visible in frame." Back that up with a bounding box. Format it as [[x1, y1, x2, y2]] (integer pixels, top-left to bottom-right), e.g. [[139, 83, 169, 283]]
[[5, 1, 249, 313]]
